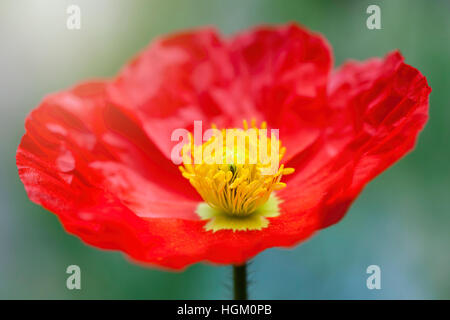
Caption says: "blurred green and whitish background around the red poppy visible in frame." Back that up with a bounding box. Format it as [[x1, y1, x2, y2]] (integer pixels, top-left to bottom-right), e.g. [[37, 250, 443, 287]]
[[0, 0, 450, 299]]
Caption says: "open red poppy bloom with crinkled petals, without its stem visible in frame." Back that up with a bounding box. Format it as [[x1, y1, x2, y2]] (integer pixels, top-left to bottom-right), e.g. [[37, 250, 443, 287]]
[[17, 24, 431, 269]]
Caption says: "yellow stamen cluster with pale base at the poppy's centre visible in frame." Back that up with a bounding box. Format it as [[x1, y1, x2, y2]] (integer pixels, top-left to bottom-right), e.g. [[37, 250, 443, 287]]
[[180, 120, 294, 231]]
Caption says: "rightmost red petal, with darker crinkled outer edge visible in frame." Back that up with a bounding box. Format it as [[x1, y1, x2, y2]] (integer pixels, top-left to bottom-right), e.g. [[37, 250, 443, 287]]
[[280, 52, 431, 228]]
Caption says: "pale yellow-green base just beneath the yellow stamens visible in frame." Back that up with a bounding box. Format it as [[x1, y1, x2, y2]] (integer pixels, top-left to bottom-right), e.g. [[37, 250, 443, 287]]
[[196, 194, 280, 232]]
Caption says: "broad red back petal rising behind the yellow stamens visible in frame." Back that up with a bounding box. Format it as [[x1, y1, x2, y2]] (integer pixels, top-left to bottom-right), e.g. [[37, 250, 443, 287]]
[[110, 24, 332, 159]]
